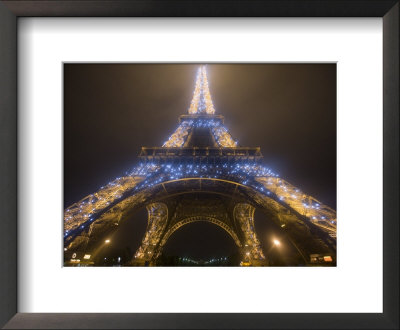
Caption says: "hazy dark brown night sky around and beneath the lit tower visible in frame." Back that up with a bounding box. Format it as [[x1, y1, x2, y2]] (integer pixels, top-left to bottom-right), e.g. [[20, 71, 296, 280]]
[[64, 63, 336, 258]]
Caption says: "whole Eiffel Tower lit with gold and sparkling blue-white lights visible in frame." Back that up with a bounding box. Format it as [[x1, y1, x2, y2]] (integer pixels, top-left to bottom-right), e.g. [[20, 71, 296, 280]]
[[64, 66, 336, 266]]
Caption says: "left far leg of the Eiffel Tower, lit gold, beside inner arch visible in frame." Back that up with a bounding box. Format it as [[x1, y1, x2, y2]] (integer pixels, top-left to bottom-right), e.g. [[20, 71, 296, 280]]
[[132, 203, 168, 266]]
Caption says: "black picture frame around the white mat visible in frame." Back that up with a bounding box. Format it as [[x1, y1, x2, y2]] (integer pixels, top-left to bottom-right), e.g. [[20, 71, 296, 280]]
[[0, 0, 399, 329]]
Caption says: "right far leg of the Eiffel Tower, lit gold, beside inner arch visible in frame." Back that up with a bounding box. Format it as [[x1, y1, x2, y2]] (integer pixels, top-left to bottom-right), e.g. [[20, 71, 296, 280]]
[[233, 203, 267, 266]]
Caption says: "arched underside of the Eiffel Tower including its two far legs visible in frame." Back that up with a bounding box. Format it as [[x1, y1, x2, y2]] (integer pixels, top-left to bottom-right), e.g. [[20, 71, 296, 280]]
[[64, 173, 336, 266]]
